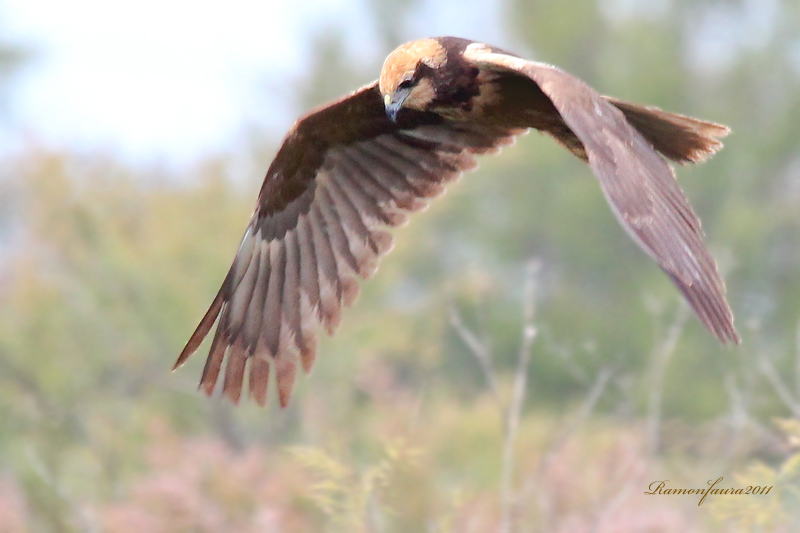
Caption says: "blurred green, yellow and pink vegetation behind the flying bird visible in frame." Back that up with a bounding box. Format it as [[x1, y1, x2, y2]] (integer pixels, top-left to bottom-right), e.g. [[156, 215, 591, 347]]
[[0, 0, 800, 532]]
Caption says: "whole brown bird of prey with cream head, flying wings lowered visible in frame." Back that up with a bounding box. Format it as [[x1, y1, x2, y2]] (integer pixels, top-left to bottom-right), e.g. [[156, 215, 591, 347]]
[[175, 37, 739, 406]]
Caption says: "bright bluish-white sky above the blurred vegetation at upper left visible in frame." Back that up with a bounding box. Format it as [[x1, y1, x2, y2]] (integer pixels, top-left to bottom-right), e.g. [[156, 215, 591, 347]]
[[0, 0, 502, 163]]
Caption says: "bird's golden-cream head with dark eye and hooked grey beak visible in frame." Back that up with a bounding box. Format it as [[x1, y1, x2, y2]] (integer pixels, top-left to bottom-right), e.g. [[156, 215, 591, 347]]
[[378, 39, 447, 121]]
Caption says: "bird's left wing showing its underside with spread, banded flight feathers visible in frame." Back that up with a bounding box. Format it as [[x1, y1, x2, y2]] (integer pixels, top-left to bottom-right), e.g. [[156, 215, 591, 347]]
[[175, 83, 524, 406]]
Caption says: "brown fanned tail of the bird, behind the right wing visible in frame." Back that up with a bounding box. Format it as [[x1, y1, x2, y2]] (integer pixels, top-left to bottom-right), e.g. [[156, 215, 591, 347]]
[[605, 96, 730, 163]]
